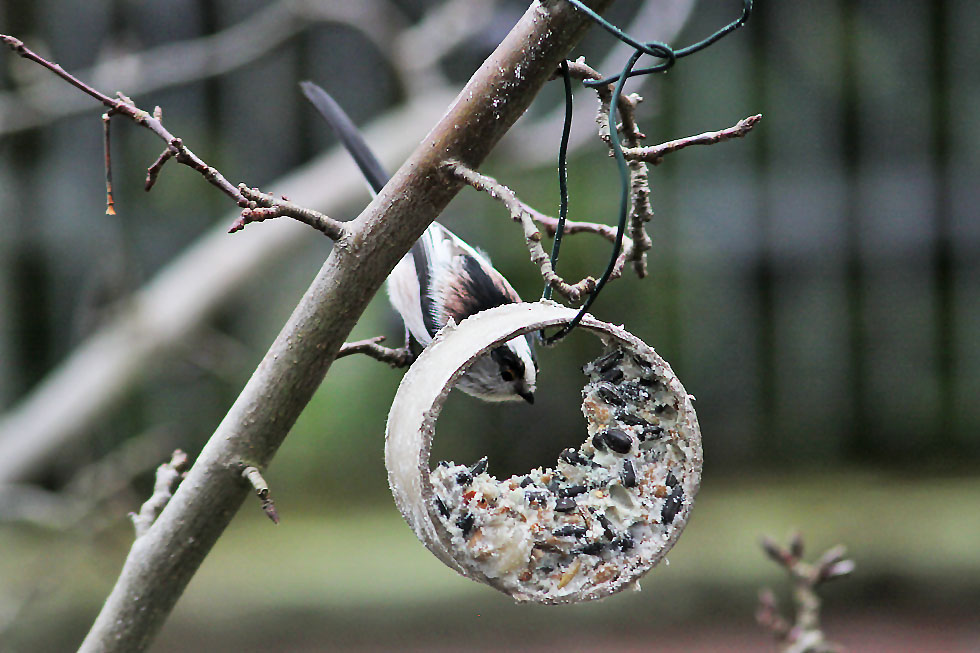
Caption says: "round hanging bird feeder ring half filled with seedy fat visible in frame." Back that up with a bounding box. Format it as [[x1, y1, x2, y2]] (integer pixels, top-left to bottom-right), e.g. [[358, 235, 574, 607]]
[[385, 302, 702, 603]]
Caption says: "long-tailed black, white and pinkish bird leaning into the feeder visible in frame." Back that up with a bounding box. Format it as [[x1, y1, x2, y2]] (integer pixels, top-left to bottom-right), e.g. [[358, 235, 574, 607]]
[[300, 81, 538, 404]]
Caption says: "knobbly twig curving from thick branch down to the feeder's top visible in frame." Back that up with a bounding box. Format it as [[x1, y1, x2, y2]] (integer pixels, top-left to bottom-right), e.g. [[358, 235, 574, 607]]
[[445, 161, 595, 302]]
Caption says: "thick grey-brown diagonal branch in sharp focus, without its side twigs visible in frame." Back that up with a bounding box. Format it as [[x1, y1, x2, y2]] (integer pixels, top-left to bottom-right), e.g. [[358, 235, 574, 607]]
[[81, 0, 609, 651]]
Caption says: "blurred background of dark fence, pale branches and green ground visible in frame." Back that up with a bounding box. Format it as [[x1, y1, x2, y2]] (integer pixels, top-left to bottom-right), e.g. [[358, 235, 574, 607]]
[[0, 0, 980, 652]]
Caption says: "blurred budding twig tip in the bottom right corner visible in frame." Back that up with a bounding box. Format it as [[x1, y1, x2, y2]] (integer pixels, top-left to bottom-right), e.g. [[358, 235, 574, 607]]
[[756, 533, 854, 653]]
